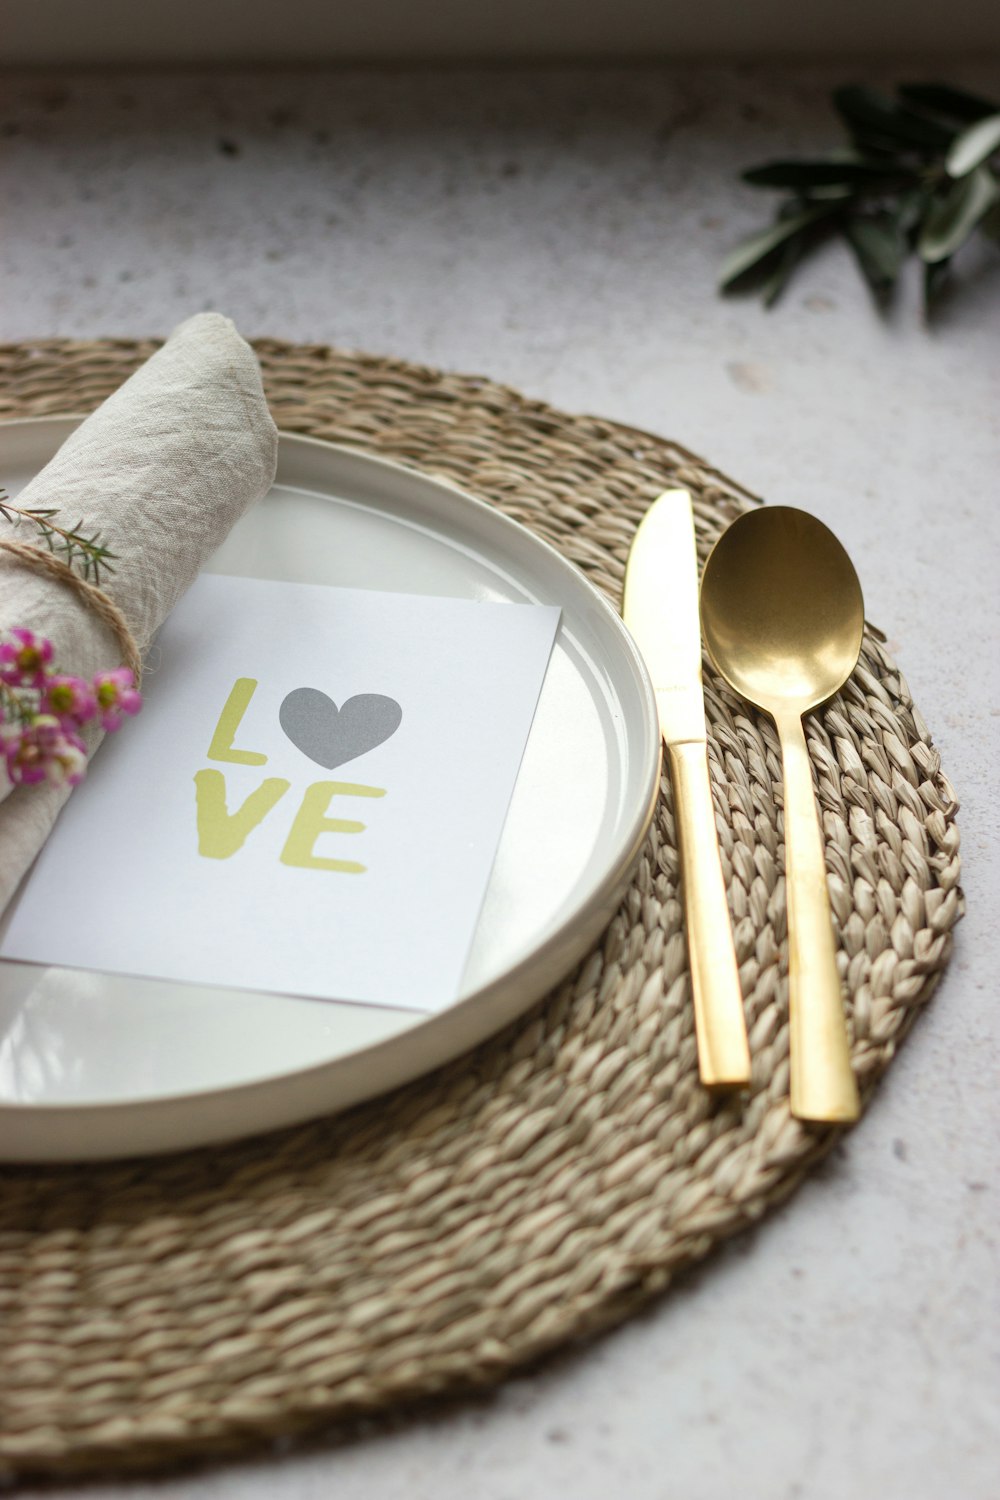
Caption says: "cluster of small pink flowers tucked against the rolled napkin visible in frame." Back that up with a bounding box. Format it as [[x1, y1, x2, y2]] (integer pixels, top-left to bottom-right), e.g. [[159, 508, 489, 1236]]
[[0, 627, 142, 786]]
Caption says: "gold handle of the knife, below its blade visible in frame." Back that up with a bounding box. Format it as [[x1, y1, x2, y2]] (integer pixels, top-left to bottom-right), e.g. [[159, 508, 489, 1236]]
[[667, 741, 750, 1089]]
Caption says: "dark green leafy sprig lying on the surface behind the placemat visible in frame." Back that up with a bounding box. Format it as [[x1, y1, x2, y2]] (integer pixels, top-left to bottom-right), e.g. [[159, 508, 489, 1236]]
[[720, 83, 1000, 309]]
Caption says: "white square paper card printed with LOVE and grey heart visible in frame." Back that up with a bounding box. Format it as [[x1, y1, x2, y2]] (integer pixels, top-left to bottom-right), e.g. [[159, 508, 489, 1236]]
[[1, 576, 559, 1011]]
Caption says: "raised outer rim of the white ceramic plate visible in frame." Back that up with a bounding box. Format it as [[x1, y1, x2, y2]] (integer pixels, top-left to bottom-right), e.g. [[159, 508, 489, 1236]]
[[0, 411, 661, 1161]]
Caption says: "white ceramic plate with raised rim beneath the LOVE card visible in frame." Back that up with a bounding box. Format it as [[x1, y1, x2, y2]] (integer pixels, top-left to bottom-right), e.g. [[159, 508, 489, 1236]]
[[0, 417, 660, 1161]]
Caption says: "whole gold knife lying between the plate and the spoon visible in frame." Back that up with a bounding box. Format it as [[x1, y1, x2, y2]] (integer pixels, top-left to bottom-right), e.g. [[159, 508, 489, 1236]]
[[622, 489, 750, 1089]]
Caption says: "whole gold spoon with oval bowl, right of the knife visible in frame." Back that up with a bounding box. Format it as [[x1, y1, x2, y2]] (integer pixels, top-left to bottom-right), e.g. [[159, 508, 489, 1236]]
[[702, 506, 865, 1122]]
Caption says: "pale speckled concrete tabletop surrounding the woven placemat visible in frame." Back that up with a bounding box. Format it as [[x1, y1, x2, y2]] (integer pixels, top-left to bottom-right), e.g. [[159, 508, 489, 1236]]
[[0, 60, 1000, 1500]]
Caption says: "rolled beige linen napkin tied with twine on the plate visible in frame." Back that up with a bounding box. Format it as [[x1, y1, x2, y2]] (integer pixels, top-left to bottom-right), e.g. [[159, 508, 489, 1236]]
[[0, 312, 277, 912]]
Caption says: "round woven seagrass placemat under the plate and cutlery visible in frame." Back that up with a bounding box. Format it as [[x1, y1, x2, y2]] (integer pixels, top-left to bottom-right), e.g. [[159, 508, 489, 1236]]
[[0, 339, 963, 1478]]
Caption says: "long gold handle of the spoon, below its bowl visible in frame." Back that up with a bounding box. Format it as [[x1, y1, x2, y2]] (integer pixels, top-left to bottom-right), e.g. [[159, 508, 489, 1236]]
[[775, 713, 861, 1124]]
